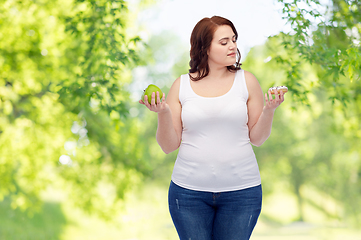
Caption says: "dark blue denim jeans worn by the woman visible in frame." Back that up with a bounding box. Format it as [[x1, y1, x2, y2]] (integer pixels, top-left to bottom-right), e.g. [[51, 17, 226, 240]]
[[168, 182, 262, 240]]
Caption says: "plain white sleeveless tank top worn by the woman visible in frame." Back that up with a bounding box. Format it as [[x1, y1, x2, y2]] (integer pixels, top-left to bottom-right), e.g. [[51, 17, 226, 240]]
[[172, 70, 261, 192]]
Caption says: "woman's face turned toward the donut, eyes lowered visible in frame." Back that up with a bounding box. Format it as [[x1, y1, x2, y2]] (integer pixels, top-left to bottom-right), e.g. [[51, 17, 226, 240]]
[[208, 25, 237, 67]]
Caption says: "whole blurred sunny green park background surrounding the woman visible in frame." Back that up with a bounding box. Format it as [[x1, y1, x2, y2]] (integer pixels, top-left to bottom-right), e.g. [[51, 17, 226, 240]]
[[0, 0, 361, 240]]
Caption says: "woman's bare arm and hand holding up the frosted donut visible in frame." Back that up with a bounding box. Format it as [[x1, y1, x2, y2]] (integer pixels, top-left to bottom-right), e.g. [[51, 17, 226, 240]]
[[245, 71, 284, 147]]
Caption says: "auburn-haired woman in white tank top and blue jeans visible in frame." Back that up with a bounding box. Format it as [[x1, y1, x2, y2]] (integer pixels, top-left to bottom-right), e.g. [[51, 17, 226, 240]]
[[140, 16, 284, 240]]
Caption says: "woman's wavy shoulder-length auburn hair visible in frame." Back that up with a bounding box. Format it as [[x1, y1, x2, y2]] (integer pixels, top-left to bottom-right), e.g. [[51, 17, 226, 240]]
[[189, 16, 242, 81]]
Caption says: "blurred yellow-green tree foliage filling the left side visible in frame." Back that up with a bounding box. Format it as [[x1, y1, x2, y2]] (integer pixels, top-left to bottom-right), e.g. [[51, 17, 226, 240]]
[[0, 0, 158, 218]]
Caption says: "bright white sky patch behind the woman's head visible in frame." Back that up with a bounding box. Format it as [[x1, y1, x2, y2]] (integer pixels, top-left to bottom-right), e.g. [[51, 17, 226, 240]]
[[134, 0, 290, 98]]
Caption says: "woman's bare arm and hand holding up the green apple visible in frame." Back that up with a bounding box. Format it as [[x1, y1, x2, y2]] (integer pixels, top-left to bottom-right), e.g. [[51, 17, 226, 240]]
[[139, 78, 182, 154]]
